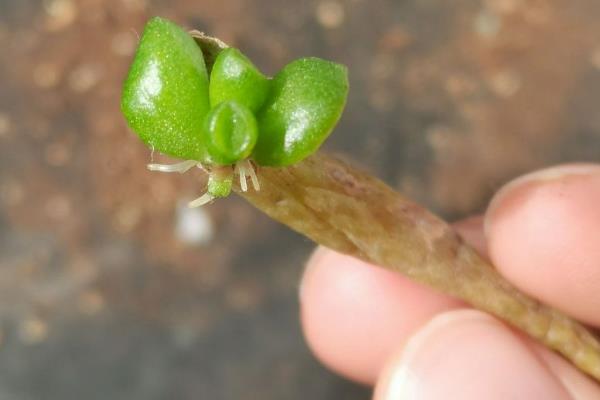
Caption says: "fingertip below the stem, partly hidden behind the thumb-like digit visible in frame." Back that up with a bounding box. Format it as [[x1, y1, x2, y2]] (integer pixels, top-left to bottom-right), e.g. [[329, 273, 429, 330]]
[[300, 248, 460, 384]]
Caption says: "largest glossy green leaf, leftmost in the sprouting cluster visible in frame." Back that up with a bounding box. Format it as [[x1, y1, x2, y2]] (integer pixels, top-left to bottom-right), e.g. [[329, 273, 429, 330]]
[[121, 17, 209, 161]]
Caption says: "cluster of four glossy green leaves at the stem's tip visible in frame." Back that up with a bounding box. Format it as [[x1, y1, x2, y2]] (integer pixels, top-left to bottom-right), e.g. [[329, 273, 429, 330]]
[[121, 17, 348, 166]]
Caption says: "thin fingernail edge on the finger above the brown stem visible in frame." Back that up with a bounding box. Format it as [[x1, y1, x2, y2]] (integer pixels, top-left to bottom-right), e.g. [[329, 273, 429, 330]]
[[483, 163, 600, 237]]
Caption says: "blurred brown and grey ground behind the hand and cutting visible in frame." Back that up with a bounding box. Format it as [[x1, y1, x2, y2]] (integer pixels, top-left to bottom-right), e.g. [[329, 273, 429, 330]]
[[0, 0, 600, 400]]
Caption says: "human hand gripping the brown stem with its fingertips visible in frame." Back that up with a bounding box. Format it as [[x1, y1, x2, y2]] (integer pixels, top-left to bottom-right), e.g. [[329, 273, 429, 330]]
[[300, 164, 600, 400]]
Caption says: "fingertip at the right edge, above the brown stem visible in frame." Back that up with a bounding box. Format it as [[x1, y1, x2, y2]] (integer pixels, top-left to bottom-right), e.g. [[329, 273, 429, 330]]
[[485, 164, 600, 325]]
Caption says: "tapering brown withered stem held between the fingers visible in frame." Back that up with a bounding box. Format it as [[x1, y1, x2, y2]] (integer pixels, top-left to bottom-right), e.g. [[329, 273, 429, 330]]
[[236, 155, 600, 381]]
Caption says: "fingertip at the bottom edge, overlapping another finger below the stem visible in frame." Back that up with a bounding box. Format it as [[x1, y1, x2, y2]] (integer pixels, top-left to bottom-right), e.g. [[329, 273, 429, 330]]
[[375, 310, 576, 400]]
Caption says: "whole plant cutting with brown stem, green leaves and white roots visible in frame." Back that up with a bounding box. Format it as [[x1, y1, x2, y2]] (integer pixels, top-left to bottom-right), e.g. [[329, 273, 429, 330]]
[[122, 18, 600, 381]]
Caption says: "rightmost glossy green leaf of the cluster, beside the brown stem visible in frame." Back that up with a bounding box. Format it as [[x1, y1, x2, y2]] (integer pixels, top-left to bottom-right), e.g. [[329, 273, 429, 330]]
[[252, 58, 348, 166]]
